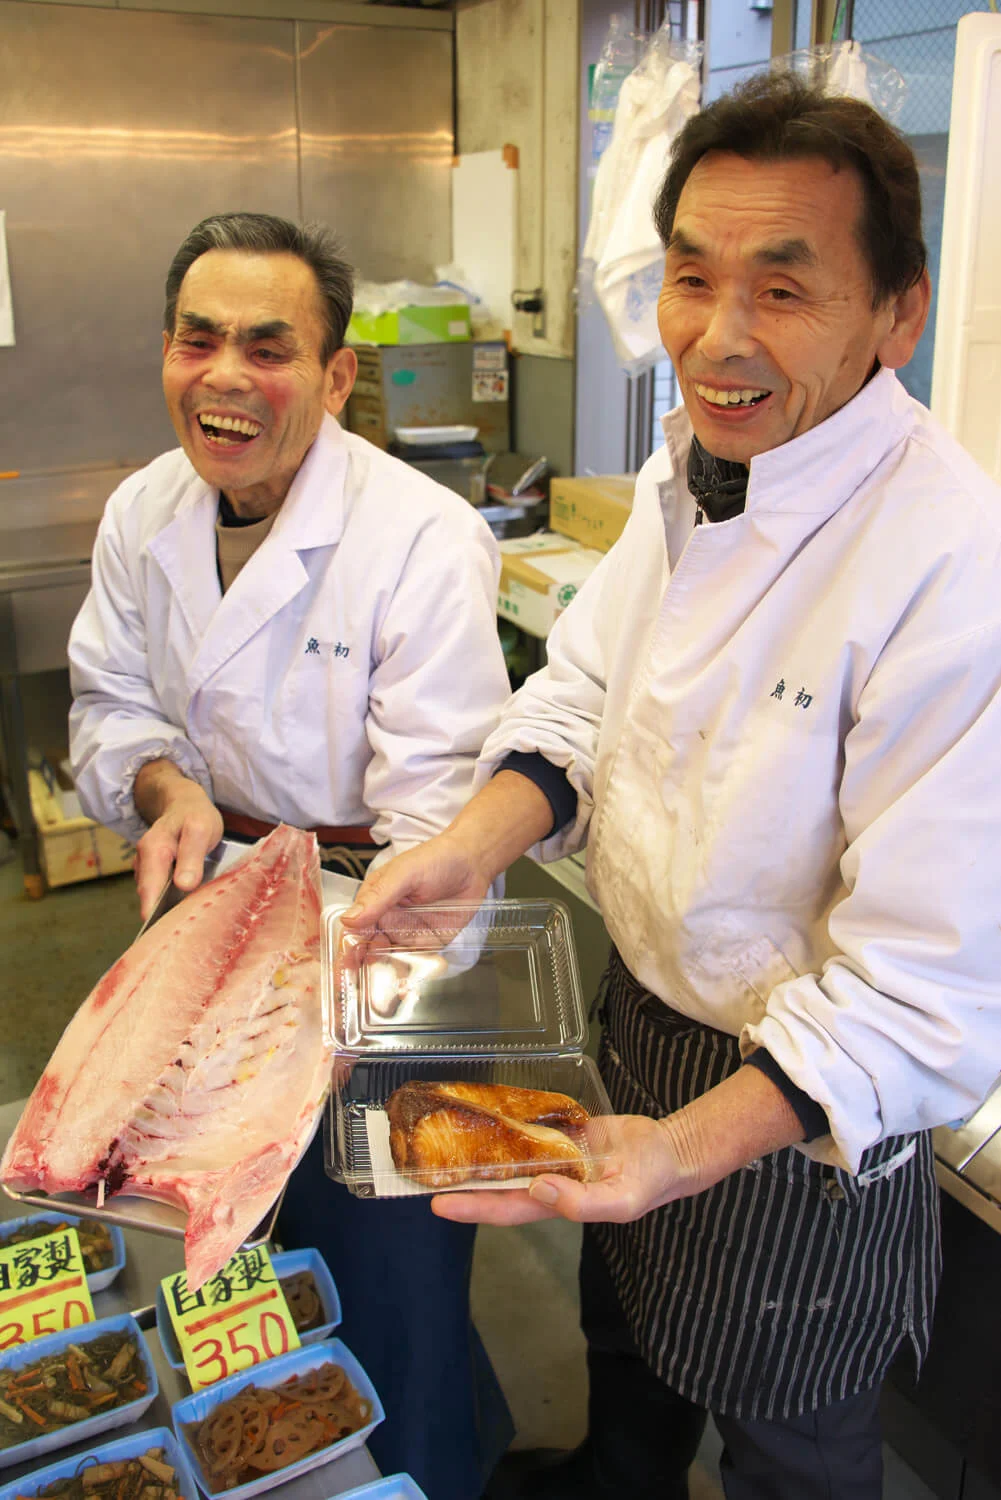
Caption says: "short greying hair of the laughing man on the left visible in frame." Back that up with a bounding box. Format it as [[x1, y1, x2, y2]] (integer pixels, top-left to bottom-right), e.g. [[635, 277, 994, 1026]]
[[164, 213, 354, 365]]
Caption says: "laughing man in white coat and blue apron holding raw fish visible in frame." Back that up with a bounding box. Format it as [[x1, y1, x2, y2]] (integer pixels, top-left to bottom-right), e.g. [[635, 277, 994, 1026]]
[[69, 215, 510, 1500]]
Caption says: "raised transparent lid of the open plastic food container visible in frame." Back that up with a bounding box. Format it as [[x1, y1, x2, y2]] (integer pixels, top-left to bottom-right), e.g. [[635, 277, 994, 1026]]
[[321, 900, 587, 1056]]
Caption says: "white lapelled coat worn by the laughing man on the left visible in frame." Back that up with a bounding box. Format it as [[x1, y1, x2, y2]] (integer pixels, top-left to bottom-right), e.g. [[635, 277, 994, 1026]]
[[69, 416, 509, 858]]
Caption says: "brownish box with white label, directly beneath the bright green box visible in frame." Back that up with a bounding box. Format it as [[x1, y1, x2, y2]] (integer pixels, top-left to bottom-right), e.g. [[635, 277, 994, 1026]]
[[347, 339, 510, 453]]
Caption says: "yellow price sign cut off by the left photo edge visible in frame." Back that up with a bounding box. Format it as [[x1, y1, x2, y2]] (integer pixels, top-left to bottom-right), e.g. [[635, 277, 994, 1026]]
[[0, 1229, 95, 1350]]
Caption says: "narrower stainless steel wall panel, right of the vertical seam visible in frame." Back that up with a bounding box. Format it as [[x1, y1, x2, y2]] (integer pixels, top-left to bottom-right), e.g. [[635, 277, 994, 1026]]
[[299, 23, 455, 281]]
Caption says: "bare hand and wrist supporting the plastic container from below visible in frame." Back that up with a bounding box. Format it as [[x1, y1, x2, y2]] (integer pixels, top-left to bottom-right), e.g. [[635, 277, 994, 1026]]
[[431, 1068, 803, 1224]]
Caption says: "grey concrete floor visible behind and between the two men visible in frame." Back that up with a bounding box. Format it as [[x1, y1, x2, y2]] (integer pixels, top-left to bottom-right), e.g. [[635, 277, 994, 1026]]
[[0, 849, 933, 1500]]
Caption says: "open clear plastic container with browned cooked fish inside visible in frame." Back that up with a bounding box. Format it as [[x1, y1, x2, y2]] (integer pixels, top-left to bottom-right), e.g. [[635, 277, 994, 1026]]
[[321, 900, 611, 1197]]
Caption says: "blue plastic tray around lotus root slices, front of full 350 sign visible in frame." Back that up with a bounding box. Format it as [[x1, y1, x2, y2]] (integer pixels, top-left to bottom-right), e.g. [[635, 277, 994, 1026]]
[[171, 1338, 386, 1500]]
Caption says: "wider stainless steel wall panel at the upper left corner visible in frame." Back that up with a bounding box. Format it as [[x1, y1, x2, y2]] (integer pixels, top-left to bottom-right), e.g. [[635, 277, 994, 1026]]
[[0, 0, 300, 474]]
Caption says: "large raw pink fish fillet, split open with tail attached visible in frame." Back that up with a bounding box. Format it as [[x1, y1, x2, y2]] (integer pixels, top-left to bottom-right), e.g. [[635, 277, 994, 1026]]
[[0, 825, 332, 1290]]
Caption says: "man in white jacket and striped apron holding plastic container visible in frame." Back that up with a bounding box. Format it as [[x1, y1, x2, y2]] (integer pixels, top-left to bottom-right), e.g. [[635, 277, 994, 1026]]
[[351, 77, 1001, 1500]]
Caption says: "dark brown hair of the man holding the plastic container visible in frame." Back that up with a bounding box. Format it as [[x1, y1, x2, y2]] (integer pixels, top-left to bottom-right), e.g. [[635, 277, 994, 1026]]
[[653, 72, 927, 308]]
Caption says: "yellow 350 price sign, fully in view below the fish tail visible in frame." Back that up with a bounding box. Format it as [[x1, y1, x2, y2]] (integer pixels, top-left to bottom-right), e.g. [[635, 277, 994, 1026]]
[[161, 1245, 299, 1391]]
